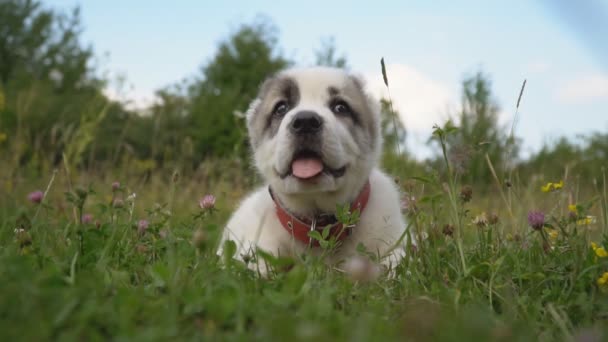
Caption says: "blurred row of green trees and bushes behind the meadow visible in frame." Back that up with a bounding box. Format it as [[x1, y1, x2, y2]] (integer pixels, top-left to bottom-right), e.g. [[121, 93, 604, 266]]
[[0, 0, 608, 184]]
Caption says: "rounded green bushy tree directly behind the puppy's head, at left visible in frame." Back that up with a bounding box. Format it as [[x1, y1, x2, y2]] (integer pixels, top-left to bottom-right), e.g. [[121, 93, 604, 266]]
[[188, 23, 289, 158]]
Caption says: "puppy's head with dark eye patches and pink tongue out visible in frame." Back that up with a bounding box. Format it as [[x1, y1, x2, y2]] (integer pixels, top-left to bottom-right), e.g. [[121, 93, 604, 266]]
[[247, 67, 381, 212]]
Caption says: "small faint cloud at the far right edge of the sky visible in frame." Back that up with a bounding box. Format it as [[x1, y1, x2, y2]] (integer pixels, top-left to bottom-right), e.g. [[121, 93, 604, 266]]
[[556, 74, 608, 103]]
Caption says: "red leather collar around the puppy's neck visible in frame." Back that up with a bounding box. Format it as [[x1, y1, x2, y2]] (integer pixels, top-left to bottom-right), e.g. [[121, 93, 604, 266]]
[[268, 181, 371, 247]]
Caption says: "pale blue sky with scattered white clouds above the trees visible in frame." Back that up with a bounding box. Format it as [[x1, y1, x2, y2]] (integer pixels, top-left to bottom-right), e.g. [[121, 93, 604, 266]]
[[43, 0, 608, 158]]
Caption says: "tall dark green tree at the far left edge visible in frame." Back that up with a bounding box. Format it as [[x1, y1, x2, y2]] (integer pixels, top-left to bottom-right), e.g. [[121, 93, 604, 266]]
[[0, 0, 121, 171]]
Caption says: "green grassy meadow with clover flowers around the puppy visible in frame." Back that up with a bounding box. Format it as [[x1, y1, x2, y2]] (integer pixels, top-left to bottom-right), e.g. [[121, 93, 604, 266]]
[[0, 156, 608, 341]]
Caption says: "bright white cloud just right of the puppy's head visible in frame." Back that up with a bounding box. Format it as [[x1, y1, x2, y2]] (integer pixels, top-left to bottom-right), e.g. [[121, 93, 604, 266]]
[[364, 64, 456, 133]]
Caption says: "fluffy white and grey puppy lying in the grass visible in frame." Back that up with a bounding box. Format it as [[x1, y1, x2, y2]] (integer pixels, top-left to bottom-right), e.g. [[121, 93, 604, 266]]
[[219, 67, 405, 268]]
